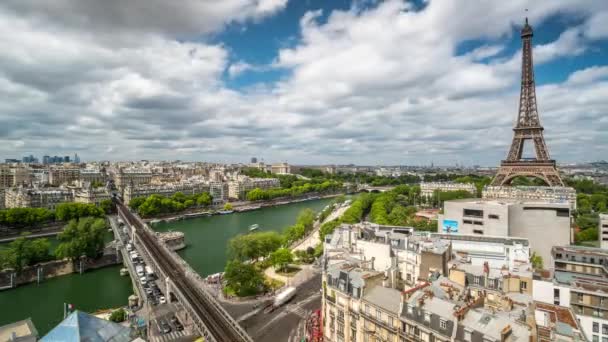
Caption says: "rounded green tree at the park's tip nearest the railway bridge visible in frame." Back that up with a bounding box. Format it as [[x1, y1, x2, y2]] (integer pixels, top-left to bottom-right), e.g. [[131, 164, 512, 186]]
[[224, 260, 264, 297]]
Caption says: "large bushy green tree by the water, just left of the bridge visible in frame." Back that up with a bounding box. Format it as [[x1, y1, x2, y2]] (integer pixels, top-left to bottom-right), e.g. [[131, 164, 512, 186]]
[[55, 217, 107, 260]]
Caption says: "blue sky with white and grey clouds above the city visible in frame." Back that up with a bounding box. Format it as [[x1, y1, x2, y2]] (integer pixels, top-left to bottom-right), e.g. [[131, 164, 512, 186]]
[[0, 0, 608, 165]]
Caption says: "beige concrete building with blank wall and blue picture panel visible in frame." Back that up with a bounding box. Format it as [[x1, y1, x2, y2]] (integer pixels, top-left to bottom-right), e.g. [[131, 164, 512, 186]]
[[438, 199, 572, 260]]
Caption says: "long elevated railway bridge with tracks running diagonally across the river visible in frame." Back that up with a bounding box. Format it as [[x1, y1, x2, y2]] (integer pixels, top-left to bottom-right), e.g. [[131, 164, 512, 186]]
[[113, 197, 253, 342]]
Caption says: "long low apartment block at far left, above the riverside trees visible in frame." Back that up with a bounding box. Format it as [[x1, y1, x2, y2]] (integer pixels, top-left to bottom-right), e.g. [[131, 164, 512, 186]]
[[5, 187, 74, 209]]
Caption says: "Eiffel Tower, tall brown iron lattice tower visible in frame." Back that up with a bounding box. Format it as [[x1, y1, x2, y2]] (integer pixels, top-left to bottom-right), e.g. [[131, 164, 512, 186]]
[[491, 18, 564, 186]]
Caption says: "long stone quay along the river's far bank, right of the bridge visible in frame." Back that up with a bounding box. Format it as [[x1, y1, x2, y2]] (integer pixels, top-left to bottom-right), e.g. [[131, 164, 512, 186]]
[[144, 193, 344, 224]]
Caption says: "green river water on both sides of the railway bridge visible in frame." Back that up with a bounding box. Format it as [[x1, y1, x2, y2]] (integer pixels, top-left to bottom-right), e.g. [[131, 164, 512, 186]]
[[0, 199, 332, 337]]
